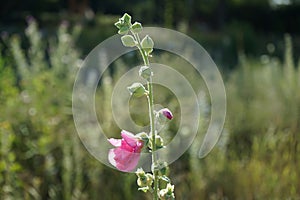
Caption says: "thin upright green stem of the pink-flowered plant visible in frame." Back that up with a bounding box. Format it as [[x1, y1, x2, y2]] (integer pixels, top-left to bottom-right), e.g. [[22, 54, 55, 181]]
[[132, 32, 158, 200]]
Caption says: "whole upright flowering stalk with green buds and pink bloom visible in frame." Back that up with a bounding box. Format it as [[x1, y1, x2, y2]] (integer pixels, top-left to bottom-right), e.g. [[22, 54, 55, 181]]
[[108, 13, 175, 200]]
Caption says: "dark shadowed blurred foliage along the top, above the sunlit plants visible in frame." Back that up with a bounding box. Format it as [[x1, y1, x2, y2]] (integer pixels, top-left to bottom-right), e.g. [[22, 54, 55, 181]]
[[0, 0, 300, 69]]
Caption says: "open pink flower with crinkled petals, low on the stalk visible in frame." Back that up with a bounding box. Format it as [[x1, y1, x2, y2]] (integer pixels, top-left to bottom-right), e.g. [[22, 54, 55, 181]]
[[108, 130, 144, 172]]
